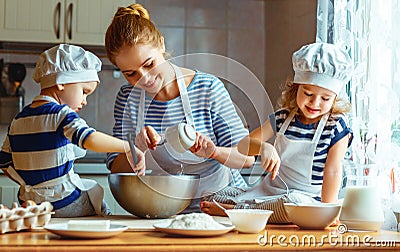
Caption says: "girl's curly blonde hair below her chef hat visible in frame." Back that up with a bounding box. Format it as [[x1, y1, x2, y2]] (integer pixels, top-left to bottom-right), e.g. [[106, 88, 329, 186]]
[[278, 80, 351, 114]]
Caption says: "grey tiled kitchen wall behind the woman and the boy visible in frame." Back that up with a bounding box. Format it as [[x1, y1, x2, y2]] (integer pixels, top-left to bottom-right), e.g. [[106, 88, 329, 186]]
[[0, 0, 265, 158]]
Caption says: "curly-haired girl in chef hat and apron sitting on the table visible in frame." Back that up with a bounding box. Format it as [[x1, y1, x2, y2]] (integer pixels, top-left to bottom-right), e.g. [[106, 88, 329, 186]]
[[201, 43, 352, 223]]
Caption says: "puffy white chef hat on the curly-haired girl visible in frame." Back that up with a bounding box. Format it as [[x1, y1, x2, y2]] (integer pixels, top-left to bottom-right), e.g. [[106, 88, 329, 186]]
[[292, 43, 353, 95]]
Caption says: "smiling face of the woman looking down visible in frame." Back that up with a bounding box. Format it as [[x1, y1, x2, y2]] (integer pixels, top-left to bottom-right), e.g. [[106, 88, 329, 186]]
[[115, 44, 169, 94]]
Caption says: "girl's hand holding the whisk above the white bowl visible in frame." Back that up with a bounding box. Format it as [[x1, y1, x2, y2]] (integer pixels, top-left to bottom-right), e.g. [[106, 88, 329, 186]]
[[260, 142, 281, 179]]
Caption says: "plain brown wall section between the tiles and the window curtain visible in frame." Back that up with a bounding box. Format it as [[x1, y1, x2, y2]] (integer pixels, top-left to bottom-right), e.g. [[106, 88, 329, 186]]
[[264, 0, 317, 105]]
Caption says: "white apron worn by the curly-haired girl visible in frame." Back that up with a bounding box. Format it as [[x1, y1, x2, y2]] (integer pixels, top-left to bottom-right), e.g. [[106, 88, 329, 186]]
[[233, 110, 329, 202]]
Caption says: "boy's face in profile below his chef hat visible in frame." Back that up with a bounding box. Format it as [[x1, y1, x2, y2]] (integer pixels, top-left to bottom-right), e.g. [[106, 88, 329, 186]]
[[57, 81, 98, 112]]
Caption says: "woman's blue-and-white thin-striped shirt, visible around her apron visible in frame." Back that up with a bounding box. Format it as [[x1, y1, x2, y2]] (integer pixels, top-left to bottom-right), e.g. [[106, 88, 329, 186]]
[[107, 71, 248, 187]]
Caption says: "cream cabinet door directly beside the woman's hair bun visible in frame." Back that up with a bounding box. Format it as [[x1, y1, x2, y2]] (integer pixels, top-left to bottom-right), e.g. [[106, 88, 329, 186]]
[[65, 0, 135, 46]]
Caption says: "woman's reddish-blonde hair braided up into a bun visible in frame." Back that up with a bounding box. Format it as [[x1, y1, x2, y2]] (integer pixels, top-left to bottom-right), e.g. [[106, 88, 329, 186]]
[[105, 4, 164, 65]]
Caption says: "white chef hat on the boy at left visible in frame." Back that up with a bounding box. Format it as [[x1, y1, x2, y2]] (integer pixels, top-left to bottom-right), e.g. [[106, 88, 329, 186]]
[[33, 44, 101, 89]]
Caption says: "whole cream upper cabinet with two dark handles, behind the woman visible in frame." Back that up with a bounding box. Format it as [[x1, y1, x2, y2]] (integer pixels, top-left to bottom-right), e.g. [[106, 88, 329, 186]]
[[0, 0, 135, 46]]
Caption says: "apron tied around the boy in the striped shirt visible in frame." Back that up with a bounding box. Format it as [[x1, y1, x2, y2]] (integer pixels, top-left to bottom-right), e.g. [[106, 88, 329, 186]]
[[7, 95, 104, 215]]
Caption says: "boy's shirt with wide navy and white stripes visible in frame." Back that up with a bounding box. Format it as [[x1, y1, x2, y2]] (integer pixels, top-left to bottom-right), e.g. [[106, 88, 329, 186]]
[[0, 99, 95, 209]]
